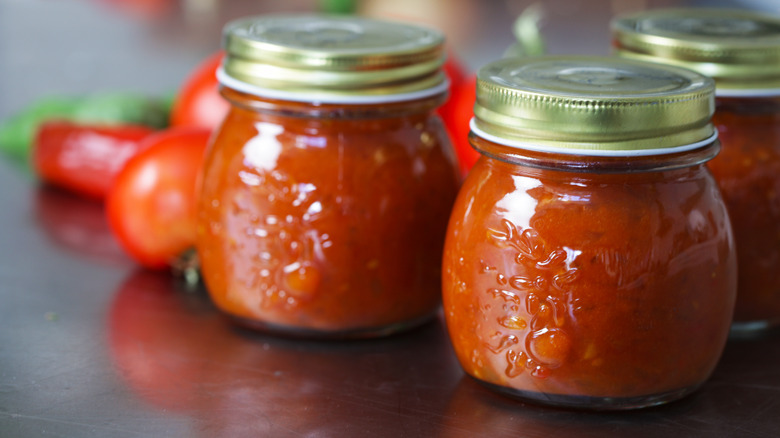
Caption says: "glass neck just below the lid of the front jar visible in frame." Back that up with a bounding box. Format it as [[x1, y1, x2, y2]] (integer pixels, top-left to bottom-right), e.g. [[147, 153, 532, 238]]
[[469, 132, 720, 173]]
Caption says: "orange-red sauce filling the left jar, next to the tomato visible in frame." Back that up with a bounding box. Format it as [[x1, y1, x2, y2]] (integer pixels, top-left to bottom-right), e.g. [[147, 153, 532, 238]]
[[198, 89, 458, 336]]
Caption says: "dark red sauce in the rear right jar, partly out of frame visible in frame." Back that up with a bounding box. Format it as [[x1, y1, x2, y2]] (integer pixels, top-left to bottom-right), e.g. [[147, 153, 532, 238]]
[[709, 98, 780, 325]]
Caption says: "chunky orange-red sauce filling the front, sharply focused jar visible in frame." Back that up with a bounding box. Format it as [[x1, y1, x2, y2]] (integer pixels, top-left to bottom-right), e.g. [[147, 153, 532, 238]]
[[443, 136, 736, 408]]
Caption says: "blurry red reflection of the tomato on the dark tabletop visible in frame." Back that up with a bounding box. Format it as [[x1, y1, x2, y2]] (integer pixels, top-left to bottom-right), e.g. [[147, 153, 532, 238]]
[[108, 269, 232, 412]]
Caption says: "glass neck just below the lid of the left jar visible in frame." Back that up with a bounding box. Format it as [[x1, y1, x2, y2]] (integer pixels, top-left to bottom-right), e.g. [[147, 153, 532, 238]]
[[220, 85, 447, 120]]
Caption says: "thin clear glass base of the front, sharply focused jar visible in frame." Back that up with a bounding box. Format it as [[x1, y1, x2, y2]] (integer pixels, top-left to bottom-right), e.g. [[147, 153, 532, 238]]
[[475, 378, 700, 411]]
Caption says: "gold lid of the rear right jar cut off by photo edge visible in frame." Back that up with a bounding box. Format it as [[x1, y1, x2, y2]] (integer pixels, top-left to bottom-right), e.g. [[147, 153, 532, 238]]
[[612, 8, 780, 95]]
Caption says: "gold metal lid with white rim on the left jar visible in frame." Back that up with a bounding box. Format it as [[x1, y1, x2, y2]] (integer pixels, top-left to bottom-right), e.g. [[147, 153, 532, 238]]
[[220, 15, 447, 103]]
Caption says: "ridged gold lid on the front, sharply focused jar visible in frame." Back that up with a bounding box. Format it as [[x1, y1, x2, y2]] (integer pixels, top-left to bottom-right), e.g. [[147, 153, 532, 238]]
[[472, 56, 716, 156]]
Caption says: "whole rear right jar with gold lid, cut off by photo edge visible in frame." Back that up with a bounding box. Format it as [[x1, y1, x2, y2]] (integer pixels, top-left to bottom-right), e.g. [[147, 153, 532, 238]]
[[612, 9, 780, 335]]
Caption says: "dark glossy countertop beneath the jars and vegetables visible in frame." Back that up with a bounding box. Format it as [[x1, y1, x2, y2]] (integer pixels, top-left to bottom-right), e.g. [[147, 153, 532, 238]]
[[0, 0, 780, 438]]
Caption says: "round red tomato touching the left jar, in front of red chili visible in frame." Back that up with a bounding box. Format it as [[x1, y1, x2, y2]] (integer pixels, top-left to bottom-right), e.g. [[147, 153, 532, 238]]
[[106, 127, 211, 269]]
